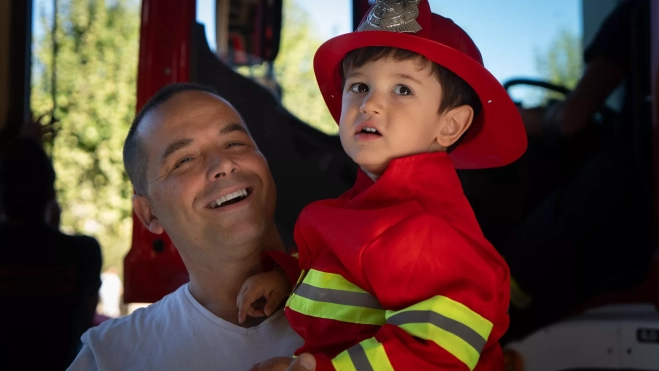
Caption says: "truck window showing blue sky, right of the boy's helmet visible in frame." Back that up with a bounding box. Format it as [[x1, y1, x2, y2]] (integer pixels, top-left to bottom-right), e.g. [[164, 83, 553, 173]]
[[430, 0, 584, 107]]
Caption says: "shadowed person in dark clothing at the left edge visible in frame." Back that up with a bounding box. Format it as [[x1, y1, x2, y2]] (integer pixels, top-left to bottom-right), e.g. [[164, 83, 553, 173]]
[[0, 137, 101, 370]]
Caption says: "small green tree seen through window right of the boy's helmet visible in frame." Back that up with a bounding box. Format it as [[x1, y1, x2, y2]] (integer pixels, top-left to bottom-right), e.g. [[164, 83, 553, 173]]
[[536, 30, 583, 99]]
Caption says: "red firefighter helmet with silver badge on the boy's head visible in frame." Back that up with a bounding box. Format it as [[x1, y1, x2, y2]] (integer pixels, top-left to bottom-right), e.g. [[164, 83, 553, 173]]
[[314, 0, 527, 169]]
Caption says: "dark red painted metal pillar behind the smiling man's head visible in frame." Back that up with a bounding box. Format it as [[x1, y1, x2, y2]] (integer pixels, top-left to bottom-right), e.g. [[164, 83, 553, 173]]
[[124, 0, 196, 303]]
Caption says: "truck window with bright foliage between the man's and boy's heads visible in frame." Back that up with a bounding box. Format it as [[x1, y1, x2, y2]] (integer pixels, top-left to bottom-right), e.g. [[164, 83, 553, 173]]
[[197, 0, 352, 135]]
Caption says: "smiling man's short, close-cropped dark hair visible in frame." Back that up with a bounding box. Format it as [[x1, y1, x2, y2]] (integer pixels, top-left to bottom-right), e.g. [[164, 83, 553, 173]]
[[124, 83, 218, 195]]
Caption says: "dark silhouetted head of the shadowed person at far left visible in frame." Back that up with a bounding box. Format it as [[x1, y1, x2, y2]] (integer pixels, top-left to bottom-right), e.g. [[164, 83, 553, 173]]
[[0, 138, 55, 221]]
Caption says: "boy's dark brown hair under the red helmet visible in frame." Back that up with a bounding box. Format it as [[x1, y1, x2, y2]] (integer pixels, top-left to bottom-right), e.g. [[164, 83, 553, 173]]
[[341, 46, 483, 152]]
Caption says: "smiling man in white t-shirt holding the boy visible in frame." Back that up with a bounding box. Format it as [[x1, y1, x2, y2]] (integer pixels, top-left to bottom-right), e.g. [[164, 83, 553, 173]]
[[70, 84, 306, 370]]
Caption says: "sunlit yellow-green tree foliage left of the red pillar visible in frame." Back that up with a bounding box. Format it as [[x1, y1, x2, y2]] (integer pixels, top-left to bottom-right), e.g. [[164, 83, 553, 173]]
[[32, 0, 140, 274]]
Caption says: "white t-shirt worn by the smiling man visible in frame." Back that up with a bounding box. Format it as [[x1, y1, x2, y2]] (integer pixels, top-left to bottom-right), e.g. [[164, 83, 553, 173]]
[[69, 284, 302, 371]]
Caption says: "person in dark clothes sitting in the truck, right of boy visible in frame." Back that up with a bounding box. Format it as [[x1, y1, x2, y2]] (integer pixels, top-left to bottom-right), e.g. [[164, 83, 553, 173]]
[[502, 0, 656, 339]]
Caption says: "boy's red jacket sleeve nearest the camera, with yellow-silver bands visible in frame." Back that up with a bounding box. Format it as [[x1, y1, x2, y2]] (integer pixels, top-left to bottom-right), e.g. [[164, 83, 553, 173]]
[[316, 215, 510, 371]]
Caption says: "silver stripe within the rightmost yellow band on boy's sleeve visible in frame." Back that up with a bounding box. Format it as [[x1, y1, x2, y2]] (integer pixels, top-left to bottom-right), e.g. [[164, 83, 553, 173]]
[[387, 310, 487, 354]]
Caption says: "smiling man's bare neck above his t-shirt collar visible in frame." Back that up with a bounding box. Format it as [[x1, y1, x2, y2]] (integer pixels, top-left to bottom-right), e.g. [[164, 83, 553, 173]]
[[186, 230, 283, 327]]
